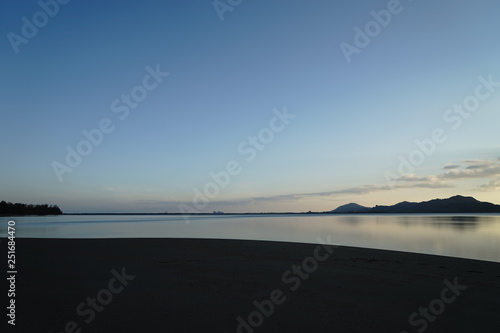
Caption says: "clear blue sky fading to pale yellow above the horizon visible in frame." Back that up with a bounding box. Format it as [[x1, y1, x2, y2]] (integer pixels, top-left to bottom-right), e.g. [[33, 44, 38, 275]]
[[0, 0, 500, 213]]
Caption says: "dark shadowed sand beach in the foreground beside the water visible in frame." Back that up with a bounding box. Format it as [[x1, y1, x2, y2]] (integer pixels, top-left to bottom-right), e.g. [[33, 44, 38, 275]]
[[7, 239, 500, 333]]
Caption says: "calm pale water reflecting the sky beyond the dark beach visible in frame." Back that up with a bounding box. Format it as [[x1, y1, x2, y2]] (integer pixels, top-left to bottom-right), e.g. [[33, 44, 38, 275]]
[[0, 214, 500, 262]]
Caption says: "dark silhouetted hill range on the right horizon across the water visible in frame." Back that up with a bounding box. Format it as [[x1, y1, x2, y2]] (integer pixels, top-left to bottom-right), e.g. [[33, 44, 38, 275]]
[[331, 195, 500, 214]]
